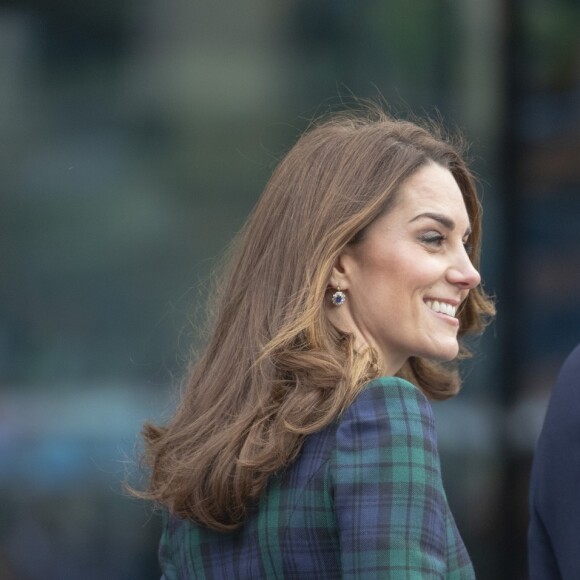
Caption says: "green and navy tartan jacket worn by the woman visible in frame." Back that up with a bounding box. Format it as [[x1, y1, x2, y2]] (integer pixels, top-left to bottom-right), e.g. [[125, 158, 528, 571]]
[[159, 377, 475, 580]]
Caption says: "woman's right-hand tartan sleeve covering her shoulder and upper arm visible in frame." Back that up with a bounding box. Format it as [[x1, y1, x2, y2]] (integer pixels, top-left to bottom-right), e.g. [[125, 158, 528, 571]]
[[329, 377, 473, 578]]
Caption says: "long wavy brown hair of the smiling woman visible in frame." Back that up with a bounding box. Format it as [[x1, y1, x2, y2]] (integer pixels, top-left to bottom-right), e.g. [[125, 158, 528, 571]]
[[135, 108, 494, 531]]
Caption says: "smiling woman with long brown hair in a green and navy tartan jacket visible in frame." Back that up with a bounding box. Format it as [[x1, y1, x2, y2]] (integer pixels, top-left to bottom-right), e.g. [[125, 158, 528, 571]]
[[139, 106, 493, 580]]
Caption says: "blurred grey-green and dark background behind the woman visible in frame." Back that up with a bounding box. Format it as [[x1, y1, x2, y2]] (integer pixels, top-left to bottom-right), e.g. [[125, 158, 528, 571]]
[[0, 0, 580, 580]]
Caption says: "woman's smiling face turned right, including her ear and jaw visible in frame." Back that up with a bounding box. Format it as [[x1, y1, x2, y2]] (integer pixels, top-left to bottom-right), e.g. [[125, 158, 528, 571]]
[[327, 163, 480, 374]]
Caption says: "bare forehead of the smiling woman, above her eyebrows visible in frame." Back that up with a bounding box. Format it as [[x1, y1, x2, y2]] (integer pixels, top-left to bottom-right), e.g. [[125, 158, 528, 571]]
[[392, 163, 469, 227]]
